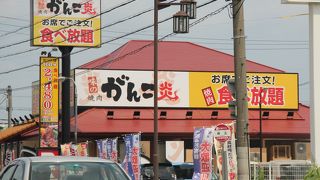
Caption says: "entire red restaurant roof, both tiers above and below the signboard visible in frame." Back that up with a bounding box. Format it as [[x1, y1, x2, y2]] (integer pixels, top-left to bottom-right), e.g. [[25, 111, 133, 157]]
[[71, 40, 310, 138]]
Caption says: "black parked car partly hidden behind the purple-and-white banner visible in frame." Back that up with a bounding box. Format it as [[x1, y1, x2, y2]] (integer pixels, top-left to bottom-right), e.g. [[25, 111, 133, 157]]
[[173, 163, 219, 180]]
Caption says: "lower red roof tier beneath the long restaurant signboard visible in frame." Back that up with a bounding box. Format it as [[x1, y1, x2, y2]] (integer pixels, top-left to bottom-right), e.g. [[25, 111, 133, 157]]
[[71, 104, 310, 138]]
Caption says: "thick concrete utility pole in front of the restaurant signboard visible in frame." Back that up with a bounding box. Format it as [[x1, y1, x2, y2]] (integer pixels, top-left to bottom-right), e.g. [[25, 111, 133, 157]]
[[232, 0, 250, 179]]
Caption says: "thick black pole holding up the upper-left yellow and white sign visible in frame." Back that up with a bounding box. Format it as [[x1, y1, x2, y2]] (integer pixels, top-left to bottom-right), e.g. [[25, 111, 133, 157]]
[[59, 46, 73, 144]]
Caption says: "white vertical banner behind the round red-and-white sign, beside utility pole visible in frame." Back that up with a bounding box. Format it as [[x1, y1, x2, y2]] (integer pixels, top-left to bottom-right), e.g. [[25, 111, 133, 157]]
[[214, 123, 238, 180]]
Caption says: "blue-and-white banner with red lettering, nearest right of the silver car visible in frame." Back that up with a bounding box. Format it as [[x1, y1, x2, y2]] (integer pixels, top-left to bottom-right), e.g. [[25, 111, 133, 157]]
[[122, 134, 141, 180]]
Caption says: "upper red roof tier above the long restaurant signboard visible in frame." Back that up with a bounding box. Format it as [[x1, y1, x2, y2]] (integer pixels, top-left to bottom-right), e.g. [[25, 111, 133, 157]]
[[80, 40, 283, 72]]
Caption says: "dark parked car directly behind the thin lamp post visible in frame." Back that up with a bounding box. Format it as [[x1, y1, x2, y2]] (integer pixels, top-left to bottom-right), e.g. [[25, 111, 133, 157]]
[[141, 163, 177, 180]]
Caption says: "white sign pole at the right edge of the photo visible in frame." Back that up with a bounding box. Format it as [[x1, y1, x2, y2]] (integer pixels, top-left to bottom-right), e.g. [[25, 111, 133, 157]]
[[281, 0, 320, 165]]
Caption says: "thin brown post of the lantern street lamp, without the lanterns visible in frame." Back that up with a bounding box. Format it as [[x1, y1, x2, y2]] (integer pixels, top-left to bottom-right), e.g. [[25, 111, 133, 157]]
[[153, 0, 159, 180]]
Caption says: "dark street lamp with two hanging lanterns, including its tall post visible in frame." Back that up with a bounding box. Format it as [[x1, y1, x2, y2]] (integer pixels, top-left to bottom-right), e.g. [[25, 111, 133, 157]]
[[153, 0, 196, 180]]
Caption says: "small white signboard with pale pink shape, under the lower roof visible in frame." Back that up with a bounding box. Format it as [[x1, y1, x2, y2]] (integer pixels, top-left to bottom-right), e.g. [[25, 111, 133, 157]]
[[166, 141, 184, 163]]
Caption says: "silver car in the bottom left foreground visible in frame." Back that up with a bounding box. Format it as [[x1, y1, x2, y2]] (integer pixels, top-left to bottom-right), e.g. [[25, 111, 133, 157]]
[[0, 156, 130, 180]]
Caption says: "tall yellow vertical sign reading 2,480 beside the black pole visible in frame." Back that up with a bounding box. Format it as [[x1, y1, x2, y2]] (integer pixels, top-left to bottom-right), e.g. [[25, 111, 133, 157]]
[[39, 57, 59, 148]]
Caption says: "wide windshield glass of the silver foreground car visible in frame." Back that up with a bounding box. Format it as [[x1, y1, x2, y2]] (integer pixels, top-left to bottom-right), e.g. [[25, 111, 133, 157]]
[[30, 162, 129, 180]]
